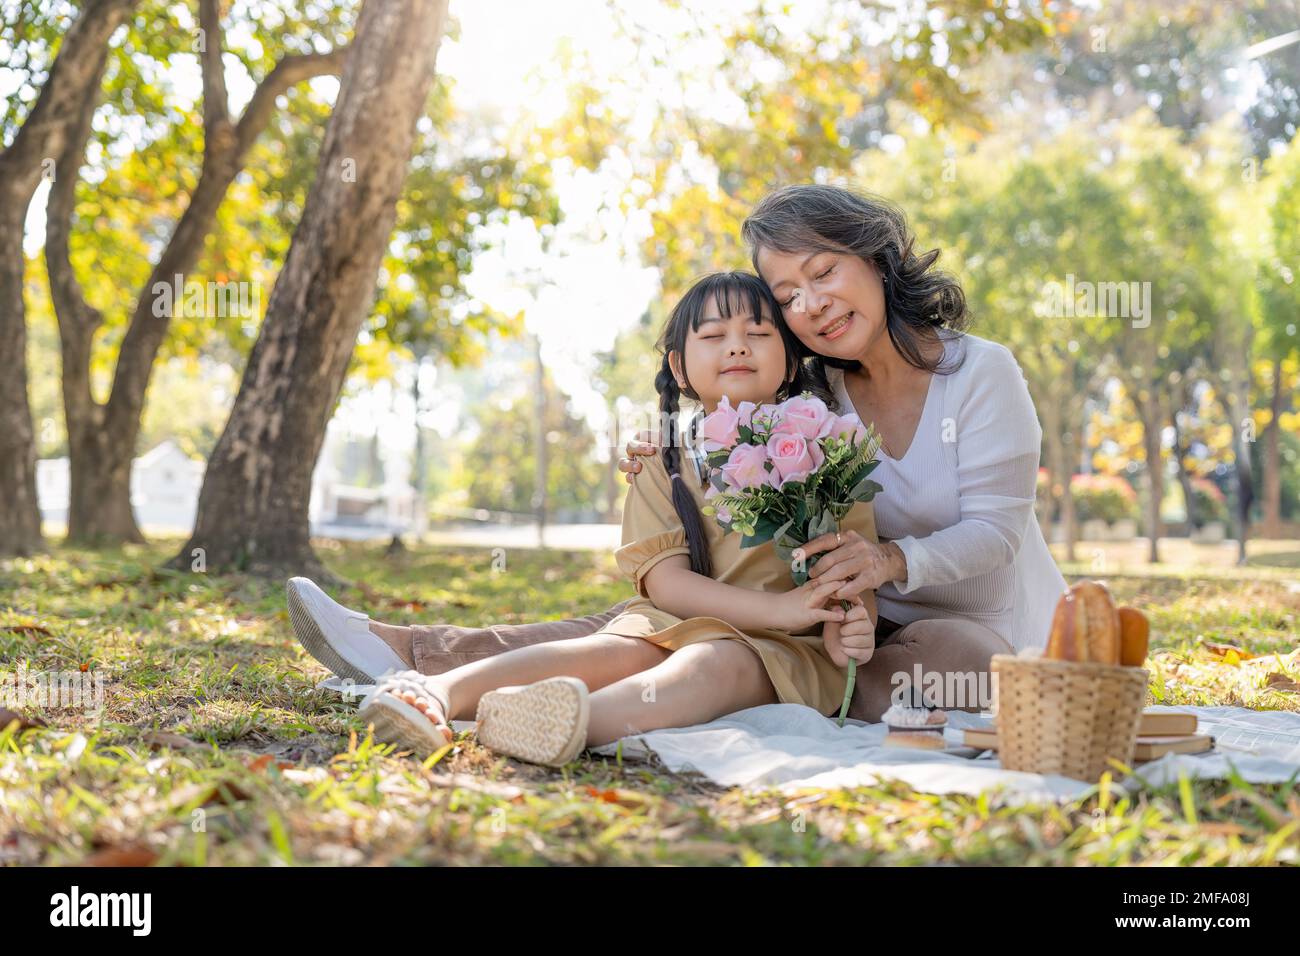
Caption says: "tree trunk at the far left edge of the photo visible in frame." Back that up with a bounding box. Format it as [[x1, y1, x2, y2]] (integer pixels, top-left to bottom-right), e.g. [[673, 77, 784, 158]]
[[0, 0, 135, 554]]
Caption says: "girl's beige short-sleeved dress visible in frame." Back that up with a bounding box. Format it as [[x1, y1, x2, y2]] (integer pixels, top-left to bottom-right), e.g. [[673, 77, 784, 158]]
[[601, 454, 876, 715]]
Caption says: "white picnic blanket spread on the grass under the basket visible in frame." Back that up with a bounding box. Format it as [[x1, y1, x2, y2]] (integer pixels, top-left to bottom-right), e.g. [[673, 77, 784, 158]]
[[321, 678, 1300, 803]]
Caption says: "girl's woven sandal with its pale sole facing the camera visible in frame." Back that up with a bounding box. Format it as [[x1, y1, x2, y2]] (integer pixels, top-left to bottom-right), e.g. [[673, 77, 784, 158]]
[[475, 678, 590, 767]]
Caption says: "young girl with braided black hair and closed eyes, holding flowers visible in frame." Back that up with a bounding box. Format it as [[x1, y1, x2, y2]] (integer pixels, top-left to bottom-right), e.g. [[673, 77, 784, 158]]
[[361, 272, 876, 766]]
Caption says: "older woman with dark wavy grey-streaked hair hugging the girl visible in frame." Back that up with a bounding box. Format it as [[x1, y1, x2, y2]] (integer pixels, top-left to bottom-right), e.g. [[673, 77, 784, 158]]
[[290, 185, 1066, 722]]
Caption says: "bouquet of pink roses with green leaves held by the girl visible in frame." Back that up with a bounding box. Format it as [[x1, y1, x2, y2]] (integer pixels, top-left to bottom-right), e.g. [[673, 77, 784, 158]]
[[697, 393, 881, 726]]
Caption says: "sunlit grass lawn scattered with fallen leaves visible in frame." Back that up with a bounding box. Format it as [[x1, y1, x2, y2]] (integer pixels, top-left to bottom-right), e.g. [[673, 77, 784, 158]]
[[0, 542, 1300, 865]]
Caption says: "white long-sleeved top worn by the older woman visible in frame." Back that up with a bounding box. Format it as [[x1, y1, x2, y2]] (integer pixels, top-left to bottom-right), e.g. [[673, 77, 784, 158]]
[[828, 334, 1066, 650]]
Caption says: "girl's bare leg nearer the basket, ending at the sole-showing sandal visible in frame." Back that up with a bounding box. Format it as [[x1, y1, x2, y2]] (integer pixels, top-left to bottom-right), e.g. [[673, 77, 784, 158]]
[[585, 639, 777, 747]]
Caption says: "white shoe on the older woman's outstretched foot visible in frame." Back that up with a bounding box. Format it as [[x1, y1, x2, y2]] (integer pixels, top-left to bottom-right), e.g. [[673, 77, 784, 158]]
[[285, 578, 410, 684]]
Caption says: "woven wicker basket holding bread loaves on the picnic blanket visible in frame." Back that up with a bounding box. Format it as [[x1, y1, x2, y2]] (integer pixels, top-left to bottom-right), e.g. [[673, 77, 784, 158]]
[[992, 654, 1149, 780]]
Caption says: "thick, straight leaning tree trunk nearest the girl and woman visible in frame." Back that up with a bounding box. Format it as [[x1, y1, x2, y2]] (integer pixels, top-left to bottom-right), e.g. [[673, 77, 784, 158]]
[[172, 0, 447, 575]]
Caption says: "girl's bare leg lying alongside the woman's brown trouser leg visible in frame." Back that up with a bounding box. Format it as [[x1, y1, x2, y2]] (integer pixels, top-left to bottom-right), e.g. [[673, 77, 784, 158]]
[[404, 633, 670, 721]]
